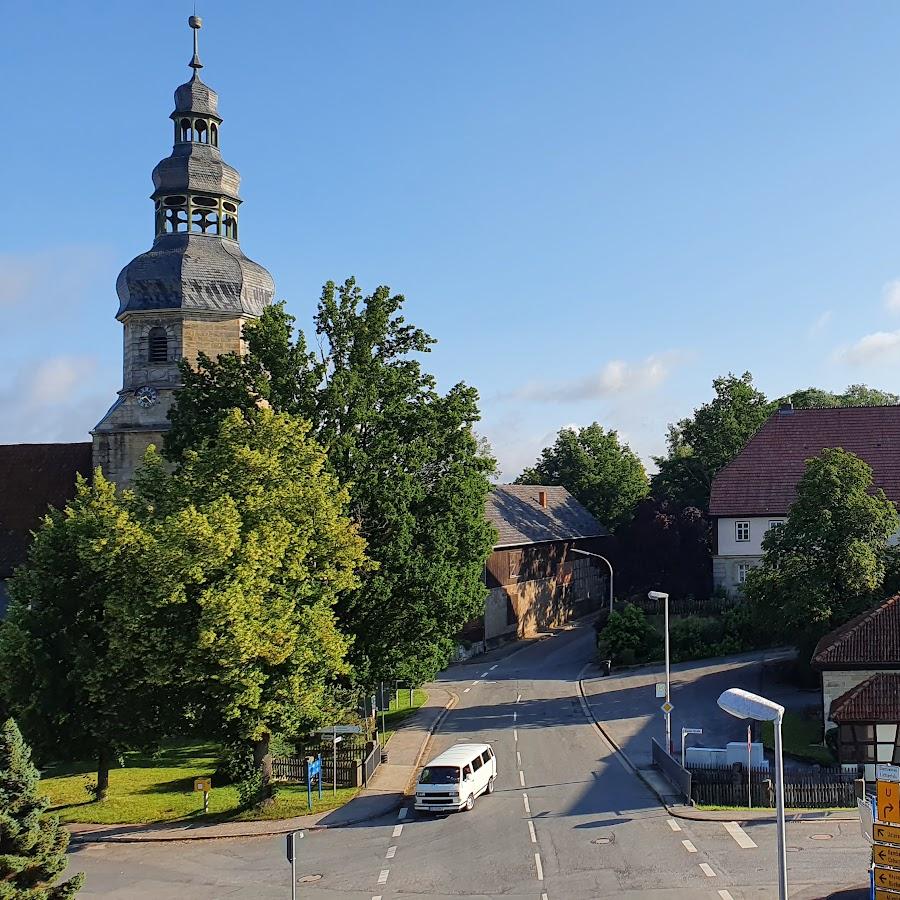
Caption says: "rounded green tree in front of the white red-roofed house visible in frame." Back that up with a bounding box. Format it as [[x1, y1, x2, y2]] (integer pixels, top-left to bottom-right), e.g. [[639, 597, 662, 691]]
[[745, 449, 900, 642]]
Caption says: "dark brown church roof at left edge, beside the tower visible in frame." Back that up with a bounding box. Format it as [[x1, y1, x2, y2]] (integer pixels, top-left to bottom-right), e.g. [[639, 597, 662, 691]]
[[0, 442, 91, 578]]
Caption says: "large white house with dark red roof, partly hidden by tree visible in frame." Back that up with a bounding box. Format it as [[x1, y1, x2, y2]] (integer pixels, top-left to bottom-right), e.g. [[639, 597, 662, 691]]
[[709, 404, 900, 592]]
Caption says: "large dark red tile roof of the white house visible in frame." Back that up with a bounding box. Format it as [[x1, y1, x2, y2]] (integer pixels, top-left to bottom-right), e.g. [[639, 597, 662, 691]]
[[709, 406, 900, 516]]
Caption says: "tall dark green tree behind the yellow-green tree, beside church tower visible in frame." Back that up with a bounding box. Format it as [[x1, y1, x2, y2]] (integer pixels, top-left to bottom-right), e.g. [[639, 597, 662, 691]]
[[166, 279, 494, 685]]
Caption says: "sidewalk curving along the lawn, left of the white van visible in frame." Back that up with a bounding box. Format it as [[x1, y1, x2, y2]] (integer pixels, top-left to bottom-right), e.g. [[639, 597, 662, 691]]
[[65, 685, 457, 844]]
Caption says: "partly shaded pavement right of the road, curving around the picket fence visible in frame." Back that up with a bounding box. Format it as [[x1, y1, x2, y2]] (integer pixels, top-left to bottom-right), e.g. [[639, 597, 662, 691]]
[[579, 650, 859, 822]]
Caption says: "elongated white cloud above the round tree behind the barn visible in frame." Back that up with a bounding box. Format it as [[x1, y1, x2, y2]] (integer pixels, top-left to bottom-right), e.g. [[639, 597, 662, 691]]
[[506, 353, 680, 403]]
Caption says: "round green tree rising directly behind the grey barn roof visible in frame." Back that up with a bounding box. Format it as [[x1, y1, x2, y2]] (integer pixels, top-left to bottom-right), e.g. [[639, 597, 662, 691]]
[[516, 422, 650, 528]]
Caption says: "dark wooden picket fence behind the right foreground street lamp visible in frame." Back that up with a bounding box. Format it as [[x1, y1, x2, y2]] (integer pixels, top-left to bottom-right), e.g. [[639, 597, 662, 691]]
[[691, 765, 856, 809]]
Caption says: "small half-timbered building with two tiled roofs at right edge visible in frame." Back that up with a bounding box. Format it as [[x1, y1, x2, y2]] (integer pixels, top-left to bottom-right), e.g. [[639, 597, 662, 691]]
[[812, 595, 900, 781]]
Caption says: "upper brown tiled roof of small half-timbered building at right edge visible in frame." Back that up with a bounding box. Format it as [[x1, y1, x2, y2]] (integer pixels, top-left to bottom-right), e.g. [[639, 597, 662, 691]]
[[812, 594, 900, 669]]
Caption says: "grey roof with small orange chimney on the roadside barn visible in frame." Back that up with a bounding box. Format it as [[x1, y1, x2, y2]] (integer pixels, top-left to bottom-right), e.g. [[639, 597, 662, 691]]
[[485, 484, 609, 549]]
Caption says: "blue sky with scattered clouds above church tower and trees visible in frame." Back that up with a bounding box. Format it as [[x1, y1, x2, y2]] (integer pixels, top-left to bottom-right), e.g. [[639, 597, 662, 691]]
[[0, 0, 900, 481]]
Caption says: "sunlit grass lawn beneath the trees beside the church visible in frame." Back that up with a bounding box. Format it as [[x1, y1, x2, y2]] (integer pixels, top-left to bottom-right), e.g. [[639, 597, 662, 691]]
[[41, 743, 357, 825]]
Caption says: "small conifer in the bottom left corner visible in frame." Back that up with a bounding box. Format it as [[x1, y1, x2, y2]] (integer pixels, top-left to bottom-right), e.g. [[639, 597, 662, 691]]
[[0, 719, 84, 900]]
